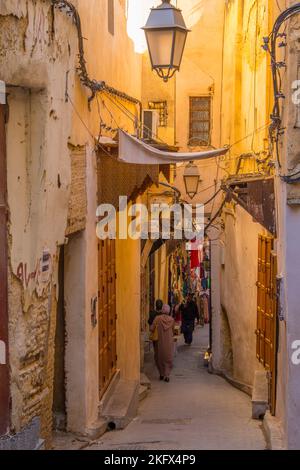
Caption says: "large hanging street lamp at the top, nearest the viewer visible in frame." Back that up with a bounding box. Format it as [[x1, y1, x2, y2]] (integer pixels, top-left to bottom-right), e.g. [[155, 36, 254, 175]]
[[143, 0, 189, 82]]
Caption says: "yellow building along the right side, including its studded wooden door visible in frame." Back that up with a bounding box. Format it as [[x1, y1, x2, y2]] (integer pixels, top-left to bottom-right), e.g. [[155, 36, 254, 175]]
[[213, 1, 299, 449]]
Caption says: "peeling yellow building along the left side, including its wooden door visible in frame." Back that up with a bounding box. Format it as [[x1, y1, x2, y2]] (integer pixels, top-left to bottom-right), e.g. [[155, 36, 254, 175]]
[[0, 0, 154, 448]]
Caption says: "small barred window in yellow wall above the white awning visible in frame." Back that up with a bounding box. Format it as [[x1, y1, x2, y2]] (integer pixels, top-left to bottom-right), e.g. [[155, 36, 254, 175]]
[[188, 96, 211, 147]]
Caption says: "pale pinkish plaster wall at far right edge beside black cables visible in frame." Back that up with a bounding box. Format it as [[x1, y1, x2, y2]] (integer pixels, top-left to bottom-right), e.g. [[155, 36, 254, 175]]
[[276, 1, 300, 449]]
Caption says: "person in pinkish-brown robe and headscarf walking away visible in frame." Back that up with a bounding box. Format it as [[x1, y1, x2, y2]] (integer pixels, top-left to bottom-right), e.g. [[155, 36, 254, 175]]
[[150, 305, 175, 382]]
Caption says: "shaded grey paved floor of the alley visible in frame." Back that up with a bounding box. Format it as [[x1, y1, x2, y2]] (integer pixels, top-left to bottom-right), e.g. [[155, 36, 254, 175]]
[[73, 327, 266, 450]]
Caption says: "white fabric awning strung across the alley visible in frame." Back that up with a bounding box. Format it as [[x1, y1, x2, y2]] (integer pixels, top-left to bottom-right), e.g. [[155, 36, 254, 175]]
[[119, 130, 228, 165]]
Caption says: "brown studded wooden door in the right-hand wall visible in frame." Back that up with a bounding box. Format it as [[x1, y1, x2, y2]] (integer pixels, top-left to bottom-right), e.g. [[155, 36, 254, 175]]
[[256, 235, 278, 415]]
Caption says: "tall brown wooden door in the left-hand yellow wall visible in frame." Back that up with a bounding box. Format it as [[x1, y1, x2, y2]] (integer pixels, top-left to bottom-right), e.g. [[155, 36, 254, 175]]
[[98, 240, 117, 398]]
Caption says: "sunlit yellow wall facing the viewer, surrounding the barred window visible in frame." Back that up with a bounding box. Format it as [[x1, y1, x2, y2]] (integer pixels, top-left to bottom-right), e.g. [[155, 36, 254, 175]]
[[142, 0, 227, 209]]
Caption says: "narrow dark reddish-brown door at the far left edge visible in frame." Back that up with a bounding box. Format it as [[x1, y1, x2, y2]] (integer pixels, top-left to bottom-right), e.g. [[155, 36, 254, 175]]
[[0, 104, 9, 436]]
